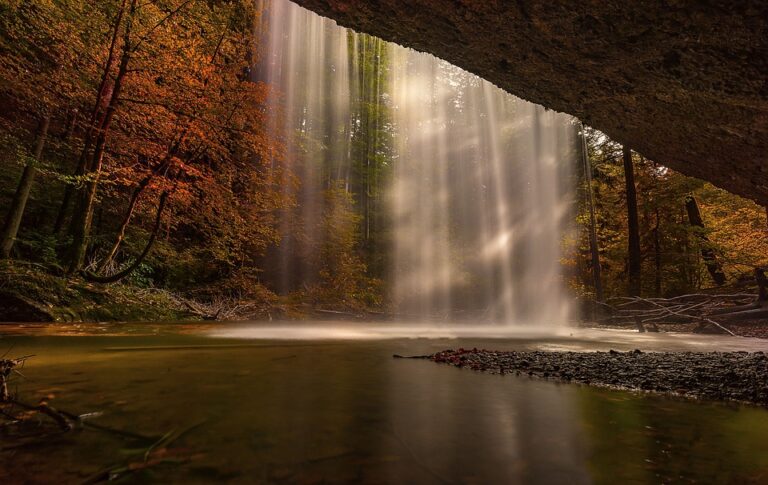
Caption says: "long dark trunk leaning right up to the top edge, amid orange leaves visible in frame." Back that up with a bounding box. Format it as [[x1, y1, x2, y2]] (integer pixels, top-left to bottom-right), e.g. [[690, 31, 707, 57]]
[[67, 0, 136, 274]]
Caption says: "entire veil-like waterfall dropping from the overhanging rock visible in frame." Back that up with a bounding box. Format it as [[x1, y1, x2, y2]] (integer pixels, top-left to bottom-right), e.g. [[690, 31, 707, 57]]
[[260, 0, 575, 325]]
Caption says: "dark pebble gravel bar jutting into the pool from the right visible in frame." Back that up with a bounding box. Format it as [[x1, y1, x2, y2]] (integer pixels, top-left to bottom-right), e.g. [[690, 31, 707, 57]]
[[428, 349, 768, 406]]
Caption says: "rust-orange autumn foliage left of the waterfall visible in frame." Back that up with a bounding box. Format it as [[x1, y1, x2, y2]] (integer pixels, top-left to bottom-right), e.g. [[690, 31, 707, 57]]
[[0, 0, 287, 298]]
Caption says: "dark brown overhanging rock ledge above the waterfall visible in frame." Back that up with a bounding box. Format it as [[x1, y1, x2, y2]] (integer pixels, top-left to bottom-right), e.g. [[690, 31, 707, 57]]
[[295, 0, 768, 205]]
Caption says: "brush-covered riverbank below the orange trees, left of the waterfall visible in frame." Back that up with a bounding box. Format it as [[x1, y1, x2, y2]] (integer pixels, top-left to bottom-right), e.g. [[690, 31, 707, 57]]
[[0, 261, 370, 323]]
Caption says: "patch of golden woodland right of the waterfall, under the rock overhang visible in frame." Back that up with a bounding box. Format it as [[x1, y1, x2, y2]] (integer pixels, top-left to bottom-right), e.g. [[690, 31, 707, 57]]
[[574, 125, 768, 298]]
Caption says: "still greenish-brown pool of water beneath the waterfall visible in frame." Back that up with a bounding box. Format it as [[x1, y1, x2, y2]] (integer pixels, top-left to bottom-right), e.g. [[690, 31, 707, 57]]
[[0, 322, 768, 483]]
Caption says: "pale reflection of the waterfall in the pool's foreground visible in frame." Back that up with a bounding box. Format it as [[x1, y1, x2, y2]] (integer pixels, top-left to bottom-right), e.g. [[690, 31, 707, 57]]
[[389, 362, 589, 483]]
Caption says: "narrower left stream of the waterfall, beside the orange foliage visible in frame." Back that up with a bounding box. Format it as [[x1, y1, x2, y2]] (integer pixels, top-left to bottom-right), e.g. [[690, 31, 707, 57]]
[[256, 0, 352, 293]]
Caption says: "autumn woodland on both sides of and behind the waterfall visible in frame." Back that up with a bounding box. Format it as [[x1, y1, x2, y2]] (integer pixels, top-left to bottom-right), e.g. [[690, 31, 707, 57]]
[[0, 0, 768, 318]]
